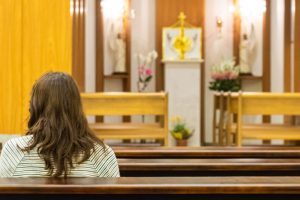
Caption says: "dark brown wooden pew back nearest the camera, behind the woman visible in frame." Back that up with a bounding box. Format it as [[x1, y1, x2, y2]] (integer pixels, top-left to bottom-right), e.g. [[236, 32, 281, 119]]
[[0, 177, 300, 200]]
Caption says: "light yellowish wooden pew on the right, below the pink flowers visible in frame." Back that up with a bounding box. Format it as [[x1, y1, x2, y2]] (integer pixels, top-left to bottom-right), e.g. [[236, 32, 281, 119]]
[[227, 92, 300, 146]]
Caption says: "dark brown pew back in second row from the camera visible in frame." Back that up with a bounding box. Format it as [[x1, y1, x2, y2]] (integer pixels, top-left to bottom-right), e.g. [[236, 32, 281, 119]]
[[118, 158, 300, 177]]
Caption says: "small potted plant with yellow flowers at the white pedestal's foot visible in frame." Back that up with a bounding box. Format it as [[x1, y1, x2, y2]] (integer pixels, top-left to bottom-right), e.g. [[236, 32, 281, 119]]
[[170, 116, 194, 146]]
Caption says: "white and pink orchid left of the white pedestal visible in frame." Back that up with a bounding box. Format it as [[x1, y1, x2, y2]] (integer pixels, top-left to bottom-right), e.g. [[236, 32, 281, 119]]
[[137, 50, 158, 92]]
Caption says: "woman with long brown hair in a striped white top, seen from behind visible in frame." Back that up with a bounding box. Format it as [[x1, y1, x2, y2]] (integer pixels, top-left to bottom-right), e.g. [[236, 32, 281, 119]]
[[0, 72, 120, 178]]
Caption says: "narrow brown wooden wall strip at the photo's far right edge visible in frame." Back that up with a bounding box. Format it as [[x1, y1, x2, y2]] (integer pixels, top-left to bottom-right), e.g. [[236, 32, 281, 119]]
[[294, 0, 300, 92]]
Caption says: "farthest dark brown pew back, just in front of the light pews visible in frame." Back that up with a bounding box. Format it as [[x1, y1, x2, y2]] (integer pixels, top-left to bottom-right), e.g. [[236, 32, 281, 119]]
[[113, 146, 300, 159]]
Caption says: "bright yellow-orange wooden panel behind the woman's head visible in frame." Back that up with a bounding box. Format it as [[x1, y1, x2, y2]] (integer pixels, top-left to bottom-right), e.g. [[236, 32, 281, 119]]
[[0, 0, 72, 134]]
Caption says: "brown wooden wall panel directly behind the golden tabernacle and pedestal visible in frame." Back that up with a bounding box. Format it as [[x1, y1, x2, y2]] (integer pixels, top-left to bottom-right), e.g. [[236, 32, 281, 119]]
[[155, 0, 206, 145]]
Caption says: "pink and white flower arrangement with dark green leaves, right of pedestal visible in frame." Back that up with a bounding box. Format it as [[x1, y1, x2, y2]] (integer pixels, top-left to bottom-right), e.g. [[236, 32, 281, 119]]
[[209, 59, 240, 92]]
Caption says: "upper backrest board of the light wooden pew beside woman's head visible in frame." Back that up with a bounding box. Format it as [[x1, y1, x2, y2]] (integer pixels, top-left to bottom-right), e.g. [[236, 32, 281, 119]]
[[81, 92, 168, 115]]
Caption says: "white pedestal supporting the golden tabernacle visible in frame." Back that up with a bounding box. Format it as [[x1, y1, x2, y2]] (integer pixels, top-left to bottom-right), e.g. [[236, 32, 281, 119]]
[[164, 61, 202, 146]]
